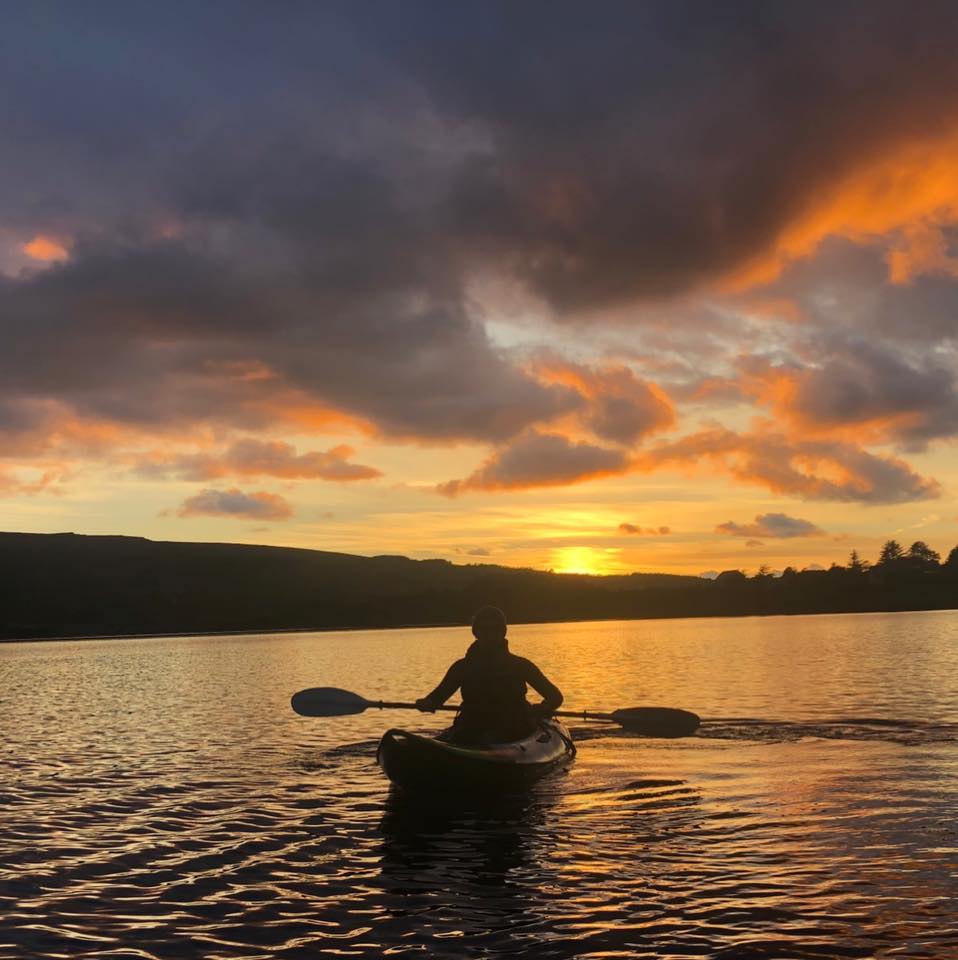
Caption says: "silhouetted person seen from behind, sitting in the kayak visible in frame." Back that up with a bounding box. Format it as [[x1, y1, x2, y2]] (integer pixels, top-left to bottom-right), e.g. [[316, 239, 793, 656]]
[[416, 607, 562, 744]]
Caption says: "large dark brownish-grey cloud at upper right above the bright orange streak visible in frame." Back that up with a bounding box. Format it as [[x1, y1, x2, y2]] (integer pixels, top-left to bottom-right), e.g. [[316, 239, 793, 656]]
[[352, 2, 958, 310]]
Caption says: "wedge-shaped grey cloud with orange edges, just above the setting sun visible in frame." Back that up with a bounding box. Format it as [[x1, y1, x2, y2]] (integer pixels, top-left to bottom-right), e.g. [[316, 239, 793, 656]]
[[437, 431, 628, 497]]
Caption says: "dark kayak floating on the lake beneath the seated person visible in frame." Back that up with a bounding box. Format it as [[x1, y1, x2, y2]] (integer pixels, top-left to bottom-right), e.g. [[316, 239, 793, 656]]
[[376, 719, 575, 792]]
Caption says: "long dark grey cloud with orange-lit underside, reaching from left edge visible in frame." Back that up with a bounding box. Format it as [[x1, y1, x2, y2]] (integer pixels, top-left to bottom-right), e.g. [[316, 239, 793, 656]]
[[0, 242, 581, 441]]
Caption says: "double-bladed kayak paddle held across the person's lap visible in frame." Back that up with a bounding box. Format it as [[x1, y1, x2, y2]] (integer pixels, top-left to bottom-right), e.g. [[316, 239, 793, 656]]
[[292, 687, 700, 737]]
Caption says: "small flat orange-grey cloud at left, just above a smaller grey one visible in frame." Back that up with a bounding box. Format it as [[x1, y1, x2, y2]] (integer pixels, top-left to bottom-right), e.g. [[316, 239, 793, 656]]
[[136, 438, 382, 483]]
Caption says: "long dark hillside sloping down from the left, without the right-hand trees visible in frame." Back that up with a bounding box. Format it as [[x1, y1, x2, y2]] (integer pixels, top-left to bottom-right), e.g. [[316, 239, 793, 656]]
[[0, 533, 699, 639]]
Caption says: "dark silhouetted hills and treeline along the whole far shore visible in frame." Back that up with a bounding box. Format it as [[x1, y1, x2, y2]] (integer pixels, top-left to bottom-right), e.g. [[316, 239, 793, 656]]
[[0, 533, 958, 640]]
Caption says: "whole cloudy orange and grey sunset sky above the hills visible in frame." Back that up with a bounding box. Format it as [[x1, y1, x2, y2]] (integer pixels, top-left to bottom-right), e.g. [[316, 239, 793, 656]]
[[0, 0, 958, 573]]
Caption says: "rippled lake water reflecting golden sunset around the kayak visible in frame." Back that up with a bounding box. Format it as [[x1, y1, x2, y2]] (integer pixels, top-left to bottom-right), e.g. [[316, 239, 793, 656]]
[[0, 612, 958, 960]]
